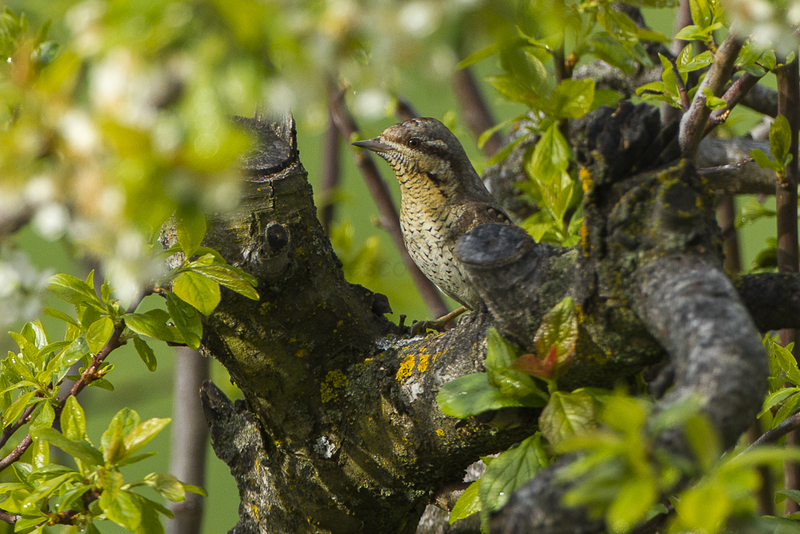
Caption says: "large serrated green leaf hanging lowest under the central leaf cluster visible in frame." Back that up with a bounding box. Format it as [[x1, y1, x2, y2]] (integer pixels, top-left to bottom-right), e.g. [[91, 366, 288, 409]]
[[478, 433, 547, 512]]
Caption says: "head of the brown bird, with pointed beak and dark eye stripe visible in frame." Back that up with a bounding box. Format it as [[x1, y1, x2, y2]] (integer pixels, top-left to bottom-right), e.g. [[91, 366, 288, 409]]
[[353, 117, 477, 187]]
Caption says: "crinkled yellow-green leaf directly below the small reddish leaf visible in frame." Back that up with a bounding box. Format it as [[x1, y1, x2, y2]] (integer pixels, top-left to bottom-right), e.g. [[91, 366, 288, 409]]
[[539, 389, 597, 445]]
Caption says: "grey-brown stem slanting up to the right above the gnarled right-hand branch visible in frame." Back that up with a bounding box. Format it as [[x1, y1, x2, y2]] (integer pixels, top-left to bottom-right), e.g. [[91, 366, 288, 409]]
[[678, 31, 742, 161]]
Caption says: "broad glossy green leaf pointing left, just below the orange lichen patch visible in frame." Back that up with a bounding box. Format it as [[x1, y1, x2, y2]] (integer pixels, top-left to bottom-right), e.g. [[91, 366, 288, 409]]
[[436, 373, 524, 419]]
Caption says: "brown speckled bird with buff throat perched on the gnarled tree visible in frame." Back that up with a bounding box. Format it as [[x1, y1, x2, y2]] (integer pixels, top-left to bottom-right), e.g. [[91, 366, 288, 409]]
[[353, 117, 512, 327]]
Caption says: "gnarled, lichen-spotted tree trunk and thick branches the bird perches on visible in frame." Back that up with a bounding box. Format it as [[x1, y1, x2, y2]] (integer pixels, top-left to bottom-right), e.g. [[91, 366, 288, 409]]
[[169, 104, 800, 534]]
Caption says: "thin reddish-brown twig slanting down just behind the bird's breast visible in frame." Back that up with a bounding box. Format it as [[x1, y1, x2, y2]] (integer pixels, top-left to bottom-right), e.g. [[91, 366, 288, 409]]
[[330, 84, 448, 317]]
